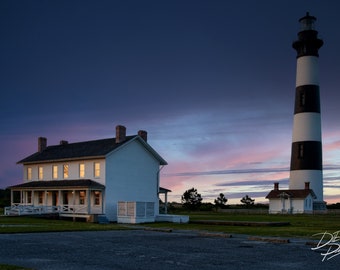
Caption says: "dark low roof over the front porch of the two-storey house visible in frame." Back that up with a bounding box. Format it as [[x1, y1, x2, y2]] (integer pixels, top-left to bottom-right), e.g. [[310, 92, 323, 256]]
[[9, 179, 105, 190]]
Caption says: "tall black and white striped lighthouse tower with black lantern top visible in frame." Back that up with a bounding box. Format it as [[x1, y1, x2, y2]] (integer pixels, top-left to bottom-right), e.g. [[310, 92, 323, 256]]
[[289, 12, 325, 210]]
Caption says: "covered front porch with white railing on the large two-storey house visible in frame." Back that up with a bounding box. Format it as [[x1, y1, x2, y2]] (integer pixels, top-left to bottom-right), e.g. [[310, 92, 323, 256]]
[[5, 179, 105, 220]]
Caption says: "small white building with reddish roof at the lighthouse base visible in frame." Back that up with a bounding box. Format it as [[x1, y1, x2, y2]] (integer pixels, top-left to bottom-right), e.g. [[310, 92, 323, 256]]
[[266, 182, 316, 214]]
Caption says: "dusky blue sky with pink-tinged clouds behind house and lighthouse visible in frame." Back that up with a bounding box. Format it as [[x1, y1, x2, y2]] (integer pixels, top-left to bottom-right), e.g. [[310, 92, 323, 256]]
[[0, 0, 340, 203]]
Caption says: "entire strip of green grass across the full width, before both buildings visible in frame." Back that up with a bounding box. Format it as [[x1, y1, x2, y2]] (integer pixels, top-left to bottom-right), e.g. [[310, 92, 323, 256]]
[[0, 212, 340, 238]]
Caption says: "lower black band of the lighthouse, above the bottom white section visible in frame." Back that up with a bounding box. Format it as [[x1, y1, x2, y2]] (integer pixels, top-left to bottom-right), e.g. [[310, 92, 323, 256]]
[[290, 141, 322, 170]]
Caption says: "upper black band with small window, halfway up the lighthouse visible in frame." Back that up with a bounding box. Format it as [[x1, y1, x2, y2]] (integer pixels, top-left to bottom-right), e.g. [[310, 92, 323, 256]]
[[294, 85, 320, 114]]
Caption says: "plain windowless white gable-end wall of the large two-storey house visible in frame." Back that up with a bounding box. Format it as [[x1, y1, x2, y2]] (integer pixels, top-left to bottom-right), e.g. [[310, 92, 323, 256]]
[[105, 140, 160, 221]]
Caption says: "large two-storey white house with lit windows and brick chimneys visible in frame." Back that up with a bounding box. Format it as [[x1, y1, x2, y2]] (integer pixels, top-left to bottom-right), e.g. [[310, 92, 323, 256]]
[[5, 126, 167, 223]]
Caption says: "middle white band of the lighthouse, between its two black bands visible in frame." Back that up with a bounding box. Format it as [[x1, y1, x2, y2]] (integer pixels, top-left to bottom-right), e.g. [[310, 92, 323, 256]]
[[293, 112, 321, 142]]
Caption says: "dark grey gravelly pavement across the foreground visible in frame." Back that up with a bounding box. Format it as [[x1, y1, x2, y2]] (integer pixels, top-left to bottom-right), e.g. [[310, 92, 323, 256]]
[[0, 230, 340, 270]]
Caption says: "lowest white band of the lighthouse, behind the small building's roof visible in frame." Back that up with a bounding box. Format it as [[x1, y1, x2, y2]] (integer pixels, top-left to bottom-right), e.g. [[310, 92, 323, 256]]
[[289, 170, 323, 201]]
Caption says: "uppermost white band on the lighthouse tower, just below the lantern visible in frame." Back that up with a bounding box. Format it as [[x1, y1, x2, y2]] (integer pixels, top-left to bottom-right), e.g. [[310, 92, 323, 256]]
[[296, 56, 319, 87]]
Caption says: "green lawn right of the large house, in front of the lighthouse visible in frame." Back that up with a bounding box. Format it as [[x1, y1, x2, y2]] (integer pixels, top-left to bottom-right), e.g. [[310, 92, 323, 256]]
[[148, 212, 340, 238]]
